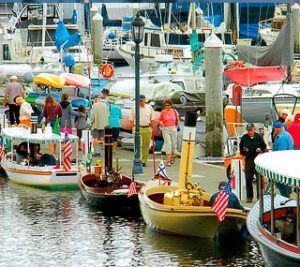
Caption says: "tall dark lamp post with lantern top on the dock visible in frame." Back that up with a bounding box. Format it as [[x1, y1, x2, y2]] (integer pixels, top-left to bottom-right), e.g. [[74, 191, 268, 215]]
[[132, 12, 145, 174]]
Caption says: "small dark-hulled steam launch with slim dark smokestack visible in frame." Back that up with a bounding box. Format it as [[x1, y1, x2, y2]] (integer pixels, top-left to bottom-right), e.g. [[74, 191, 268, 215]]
[[79, 127, 144, 212]]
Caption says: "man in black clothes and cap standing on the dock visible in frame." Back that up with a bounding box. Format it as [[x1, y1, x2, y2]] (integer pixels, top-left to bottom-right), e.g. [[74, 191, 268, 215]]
[[239, 123, 267, 203]]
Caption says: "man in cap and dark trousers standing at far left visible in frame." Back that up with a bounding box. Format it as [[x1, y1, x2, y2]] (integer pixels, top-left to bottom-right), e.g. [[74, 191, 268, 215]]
[[4, 75, 24, 125]]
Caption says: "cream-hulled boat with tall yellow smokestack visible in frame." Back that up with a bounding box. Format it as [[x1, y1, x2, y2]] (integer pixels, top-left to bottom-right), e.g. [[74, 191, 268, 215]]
[[139, 112, 247, 238]]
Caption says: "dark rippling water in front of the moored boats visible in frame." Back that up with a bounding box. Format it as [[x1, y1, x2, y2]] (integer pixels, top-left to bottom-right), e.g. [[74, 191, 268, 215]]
[[0, 178, 264, 267]]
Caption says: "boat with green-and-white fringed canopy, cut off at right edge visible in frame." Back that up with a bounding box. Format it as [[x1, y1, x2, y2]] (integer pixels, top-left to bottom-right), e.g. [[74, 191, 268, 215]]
[[247, 150, 300, 267]]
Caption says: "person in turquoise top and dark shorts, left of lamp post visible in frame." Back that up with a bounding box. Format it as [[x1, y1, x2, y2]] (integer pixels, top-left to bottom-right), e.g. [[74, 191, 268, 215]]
[[107, 96, 123, 152]]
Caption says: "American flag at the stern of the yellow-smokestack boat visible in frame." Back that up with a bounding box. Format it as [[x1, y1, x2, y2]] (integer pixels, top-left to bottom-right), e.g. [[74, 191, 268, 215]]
[[211, 179, 231, 222]]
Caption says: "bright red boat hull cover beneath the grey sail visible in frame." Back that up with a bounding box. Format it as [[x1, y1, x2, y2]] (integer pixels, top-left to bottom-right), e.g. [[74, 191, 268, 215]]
[[224, 67, 287, 86]]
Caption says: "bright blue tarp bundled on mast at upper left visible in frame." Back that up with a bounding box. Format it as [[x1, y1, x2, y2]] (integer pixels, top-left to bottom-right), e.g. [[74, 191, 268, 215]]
[[55, 21, 80, 50]]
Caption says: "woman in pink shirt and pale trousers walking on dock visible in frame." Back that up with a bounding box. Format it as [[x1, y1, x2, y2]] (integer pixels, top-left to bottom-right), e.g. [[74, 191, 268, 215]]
[[158, 99, 179, 166]]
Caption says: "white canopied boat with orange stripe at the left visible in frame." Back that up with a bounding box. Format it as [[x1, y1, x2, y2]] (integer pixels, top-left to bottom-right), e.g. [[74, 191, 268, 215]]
[[1, 127, 83, 190]]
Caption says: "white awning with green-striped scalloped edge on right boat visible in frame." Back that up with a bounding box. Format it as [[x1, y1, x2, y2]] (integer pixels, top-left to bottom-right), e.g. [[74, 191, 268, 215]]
[[255, 150, 300, 188]]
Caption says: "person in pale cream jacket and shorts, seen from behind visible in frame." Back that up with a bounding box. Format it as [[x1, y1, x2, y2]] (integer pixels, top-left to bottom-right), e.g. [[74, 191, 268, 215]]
[[91, 96, 109, 157]]
